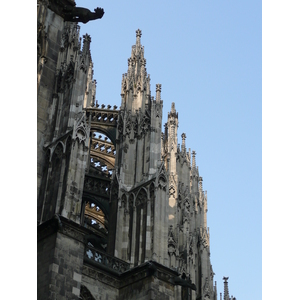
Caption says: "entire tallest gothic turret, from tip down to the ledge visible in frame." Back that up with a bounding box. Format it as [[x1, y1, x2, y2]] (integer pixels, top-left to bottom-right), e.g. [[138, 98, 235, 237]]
[[108, 30, 168, 266]]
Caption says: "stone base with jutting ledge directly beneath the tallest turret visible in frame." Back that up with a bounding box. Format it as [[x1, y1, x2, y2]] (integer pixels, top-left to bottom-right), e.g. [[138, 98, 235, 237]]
[[81, 261, 181, 300]]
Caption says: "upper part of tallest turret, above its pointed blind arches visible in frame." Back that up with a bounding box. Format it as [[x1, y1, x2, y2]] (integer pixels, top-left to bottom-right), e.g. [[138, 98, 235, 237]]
[[116, 29, 162, 189]]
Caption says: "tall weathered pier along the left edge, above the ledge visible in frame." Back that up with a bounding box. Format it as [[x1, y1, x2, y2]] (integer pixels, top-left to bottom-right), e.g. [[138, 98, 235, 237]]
[[37, 1, 95, 223]]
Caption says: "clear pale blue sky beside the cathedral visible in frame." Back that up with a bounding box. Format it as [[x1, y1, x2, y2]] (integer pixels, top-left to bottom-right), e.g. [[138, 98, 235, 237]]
[[76, 0, 262, 300]]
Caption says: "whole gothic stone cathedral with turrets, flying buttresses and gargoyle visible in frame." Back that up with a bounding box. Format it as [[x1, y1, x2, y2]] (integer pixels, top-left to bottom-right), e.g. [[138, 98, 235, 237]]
[[37, 0, 235, 300]]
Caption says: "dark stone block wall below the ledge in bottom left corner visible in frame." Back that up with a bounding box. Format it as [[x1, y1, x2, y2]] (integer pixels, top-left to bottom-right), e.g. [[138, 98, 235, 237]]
[[37, 218, 84, 299]]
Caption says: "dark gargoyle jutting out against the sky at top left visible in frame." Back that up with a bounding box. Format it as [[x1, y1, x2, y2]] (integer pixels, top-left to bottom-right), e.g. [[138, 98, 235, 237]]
[[62, 5, 104, 24]]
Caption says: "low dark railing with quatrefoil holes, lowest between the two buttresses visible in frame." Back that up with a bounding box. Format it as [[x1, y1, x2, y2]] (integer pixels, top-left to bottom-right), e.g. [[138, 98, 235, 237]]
[[84, 245, 130, 273]]
